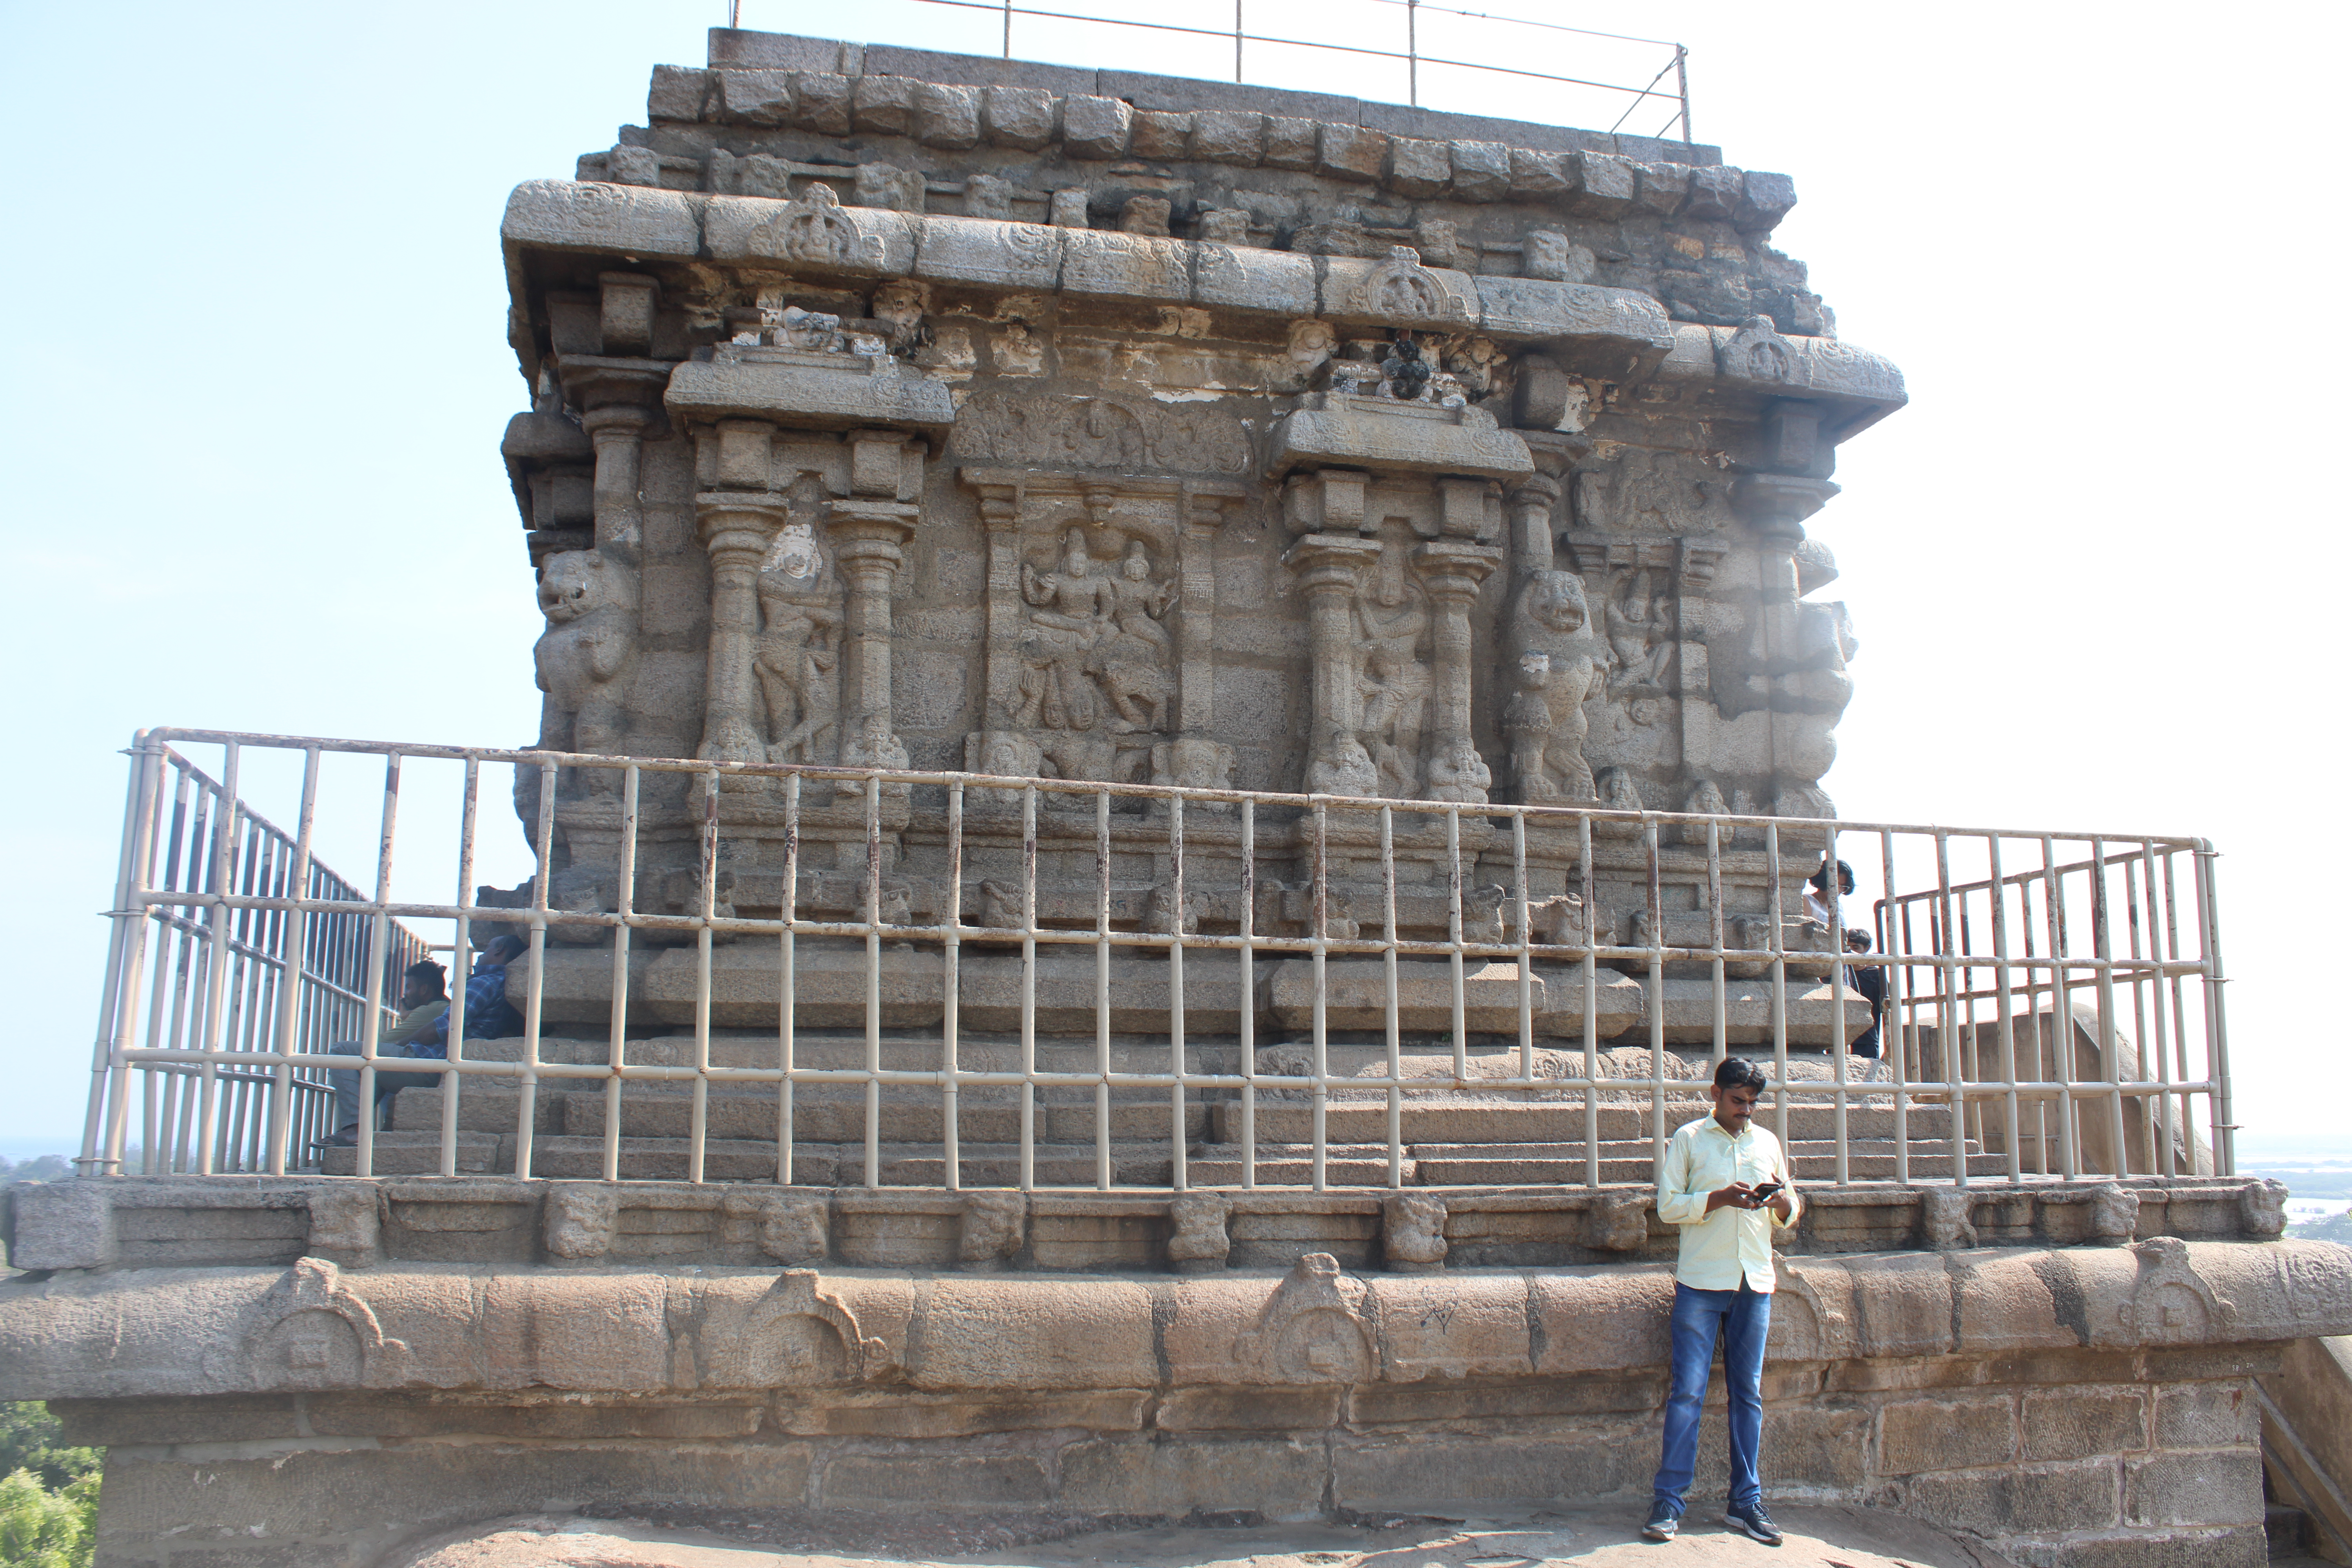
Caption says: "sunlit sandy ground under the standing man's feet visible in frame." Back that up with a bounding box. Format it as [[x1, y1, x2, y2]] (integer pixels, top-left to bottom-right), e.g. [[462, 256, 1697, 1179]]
[[381, 1507, 2009, 1568]]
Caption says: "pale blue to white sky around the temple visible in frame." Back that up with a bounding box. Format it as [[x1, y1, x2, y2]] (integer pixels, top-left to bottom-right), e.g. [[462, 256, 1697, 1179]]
[[0, 0, 2352, 1150]]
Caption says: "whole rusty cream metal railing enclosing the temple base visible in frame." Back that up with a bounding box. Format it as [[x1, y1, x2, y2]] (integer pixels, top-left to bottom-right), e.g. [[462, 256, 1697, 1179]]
[[82, 729, 2232, 1189]]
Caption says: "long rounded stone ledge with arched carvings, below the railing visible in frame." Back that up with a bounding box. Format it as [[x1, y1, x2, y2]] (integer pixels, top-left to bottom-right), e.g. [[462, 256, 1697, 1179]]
[[0, 1241, 2352, 1399]]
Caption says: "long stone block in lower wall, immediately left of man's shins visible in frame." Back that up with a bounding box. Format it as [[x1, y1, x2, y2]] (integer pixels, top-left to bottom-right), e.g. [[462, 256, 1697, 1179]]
[[1331, 1434, 1628, 1512]]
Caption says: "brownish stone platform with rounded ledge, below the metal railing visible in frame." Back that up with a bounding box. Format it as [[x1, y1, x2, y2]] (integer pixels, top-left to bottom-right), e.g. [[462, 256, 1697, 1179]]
[[0, 1222, 2352, 1568]]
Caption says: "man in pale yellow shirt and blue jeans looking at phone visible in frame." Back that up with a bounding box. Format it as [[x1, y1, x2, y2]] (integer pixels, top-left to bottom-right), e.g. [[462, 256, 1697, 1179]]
[[1642, 1056, 1797, 1547]]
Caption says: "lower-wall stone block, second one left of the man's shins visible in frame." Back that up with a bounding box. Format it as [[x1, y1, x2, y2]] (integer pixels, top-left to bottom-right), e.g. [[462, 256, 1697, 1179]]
[[1058, 1439, 1331, 1519]]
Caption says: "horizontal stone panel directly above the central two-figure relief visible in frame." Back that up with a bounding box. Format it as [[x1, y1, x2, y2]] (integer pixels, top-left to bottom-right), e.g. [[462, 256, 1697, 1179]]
[[955, 390, 1251, 475]]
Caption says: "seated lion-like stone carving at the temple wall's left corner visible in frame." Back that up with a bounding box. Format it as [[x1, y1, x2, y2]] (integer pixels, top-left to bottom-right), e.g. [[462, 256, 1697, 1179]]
[[532, 550, 637, 792]]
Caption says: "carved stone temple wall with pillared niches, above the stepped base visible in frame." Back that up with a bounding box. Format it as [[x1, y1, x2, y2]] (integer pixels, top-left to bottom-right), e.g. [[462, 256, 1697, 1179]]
[[503, 33, 1903, 945]]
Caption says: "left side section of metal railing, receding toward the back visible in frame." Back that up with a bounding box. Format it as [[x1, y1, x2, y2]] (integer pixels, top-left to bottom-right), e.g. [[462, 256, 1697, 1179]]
[[82, 745, 426, 1173]]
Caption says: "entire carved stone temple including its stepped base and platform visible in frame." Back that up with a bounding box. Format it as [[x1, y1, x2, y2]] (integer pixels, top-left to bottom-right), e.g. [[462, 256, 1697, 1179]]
[[0, 31, 2352, 1568]]
